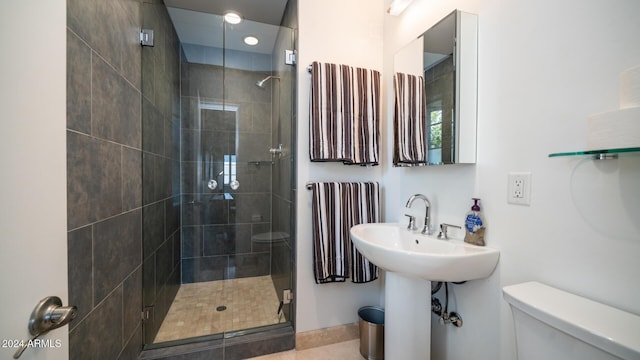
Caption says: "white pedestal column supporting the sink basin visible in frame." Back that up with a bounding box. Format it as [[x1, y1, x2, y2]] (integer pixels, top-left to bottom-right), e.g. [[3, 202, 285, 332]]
[[384, 271, 431, 360]]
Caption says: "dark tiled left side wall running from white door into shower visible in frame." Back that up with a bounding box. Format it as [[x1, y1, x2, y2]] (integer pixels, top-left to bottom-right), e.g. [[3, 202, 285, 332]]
[[67, 0, 180, 360]]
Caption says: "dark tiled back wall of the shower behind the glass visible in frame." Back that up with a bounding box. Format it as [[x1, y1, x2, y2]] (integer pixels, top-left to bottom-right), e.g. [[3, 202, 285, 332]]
[[181, 61, 272, 283]]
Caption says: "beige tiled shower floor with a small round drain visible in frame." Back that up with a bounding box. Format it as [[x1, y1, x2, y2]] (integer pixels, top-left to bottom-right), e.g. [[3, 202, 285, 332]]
[[154, 276, 285, 343]]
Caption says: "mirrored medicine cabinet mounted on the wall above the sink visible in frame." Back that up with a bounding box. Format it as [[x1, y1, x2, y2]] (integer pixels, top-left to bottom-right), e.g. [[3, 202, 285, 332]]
[[394, 10, 478, 165]]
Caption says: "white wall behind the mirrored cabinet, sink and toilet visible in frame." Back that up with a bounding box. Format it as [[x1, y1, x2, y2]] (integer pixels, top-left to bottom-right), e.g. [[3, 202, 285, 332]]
[[382, 0, 640, 360]]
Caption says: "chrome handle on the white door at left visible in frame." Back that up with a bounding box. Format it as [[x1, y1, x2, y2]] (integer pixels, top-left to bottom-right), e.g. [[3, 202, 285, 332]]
[[13, 296, 78, 359]]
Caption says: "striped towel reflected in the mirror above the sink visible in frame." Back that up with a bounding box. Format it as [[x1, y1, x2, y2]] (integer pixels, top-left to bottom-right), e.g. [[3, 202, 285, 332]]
[[393, 73, 428, 166]]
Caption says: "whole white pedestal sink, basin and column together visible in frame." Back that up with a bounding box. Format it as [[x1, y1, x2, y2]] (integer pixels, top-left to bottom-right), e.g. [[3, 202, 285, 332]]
[[351, 223, 500, 359]]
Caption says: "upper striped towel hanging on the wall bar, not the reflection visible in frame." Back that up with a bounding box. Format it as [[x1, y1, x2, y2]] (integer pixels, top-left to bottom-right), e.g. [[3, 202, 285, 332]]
[[309, 62, 380, 165]]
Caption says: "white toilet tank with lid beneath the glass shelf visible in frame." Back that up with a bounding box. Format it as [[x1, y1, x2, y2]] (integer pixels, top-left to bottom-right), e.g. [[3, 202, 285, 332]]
[[502, 282, 640, 360]]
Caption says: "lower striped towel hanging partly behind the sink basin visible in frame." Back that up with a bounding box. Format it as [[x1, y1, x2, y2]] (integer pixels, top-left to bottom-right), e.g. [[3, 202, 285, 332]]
[[312, 182, 380, 284]]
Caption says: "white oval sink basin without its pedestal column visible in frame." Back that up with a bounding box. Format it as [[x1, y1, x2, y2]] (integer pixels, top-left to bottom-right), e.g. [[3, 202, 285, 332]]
[[351, 223, 500, 282]]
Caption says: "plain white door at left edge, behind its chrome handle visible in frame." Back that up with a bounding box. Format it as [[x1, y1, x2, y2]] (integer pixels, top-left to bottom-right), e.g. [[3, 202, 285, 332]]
[[0, 0, 69, 360]]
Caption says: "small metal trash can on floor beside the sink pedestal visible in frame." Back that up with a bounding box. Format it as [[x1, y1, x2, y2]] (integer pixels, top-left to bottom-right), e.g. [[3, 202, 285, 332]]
[[358, 306, 384, 360]]
